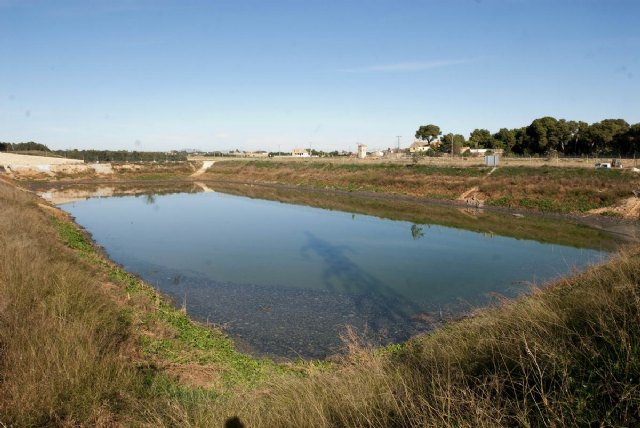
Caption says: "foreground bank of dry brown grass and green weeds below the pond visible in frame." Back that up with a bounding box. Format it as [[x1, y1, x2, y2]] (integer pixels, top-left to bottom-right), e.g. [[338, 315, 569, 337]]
[[0, 176, 640, 427]]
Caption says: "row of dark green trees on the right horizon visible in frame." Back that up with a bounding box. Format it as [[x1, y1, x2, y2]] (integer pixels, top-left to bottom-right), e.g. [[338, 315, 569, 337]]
[[415, 116, 640, 156]]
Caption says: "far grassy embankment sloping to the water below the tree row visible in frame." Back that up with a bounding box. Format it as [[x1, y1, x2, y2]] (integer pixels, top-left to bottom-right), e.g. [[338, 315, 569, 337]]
[[201, 161, 640, 213]]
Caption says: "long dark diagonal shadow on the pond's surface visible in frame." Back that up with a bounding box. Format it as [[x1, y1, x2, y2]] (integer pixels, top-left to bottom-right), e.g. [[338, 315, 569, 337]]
[[301, 232, 418, 330]]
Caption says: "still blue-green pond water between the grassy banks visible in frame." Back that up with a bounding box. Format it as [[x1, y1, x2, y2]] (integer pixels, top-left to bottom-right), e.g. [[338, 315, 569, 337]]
[[61, 192, 606, 358]]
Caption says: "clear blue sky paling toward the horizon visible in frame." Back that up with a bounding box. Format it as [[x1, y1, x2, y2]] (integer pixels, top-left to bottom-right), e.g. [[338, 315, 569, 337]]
[[0, 0, 640, 151]]
